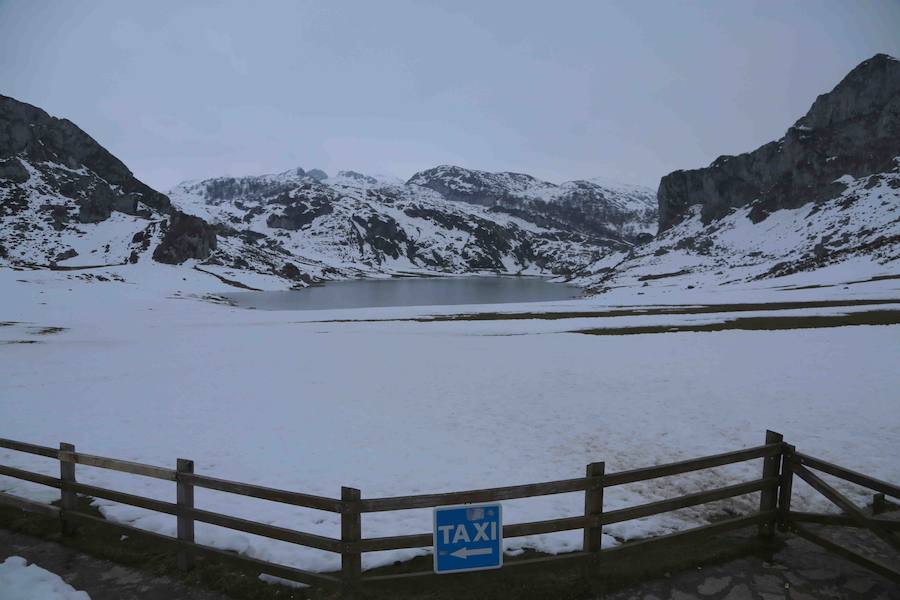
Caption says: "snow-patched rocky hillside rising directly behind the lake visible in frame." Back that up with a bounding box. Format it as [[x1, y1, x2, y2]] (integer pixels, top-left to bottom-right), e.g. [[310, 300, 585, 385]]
[[169, 169, 644, 278]]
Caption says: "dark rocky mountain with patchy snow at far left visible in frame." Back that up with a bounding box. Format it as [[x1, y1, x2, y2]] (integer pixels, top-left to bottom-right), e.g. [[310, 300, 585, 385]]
[[0, 96, 216, 267]]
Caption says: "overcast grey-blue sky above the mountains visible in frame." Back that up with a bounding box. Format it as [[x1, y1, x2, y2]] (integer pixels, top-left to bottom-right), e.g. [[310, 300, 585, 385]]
[[0, 0, 900, 191]]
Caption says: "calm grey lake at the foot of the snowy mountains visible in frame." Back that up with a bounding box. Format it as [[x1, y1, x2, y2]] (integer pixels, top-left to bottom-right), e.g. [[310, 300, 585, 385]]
[[223, 276, 582, 310]]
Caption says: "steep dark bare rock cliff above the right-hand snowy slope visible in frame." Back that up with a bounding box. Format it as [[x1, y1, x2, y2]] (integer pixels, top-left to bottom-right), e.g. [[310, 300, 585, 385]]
[[657, 54, 900, 232]]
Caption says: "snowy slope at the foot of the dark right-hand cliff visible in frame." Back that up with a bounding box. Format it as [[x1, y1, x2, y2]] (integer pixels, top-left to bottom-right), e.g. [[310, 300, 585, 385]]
[[575, 169, 900, 292]]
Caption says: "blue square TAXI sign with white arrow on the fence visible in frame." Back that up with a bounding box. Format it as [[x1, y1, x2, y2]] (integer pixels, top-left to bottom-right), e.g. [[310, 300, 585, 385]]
[[434, 503, 503, 573]]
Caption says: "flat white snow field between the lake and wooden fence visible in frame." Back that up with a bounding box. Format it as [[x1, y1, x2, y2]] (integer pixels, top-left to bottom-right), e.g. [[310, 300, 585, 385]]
[[0, 269, 900, 570]]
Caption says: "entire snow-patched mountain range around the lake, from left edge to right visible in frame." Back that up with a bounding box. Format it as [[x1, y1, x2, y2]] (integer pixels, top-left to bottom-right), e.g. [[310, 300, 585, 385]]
[[0, 55, 900, 291]]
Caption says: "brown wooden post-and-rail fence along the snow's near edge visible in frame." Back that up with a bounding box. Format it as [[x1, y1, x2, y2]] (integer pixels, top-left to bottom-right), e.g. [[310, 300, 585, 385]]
[[0, 431, 900, 597]]
